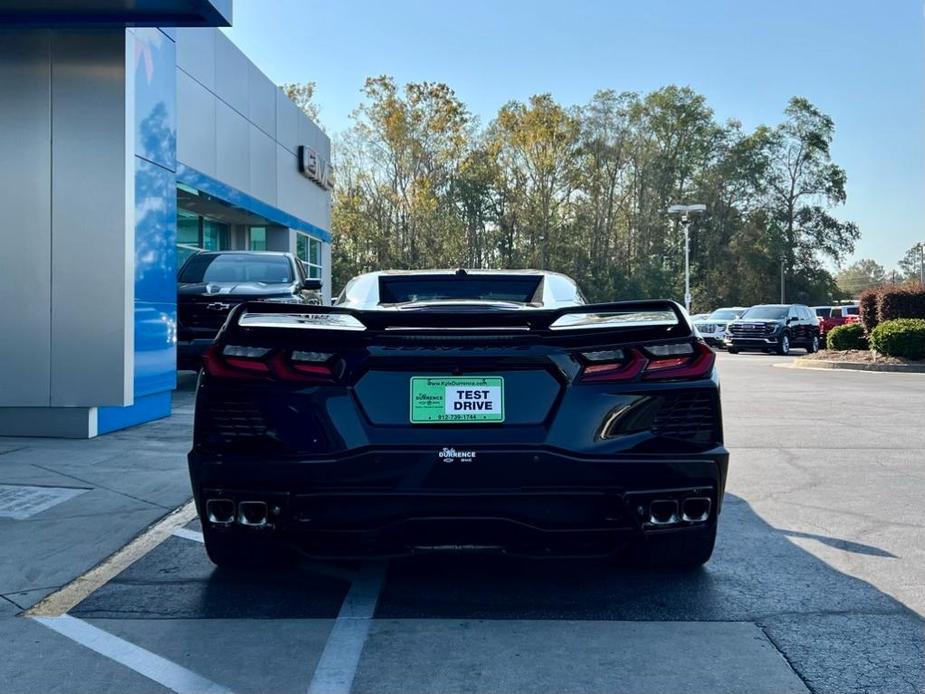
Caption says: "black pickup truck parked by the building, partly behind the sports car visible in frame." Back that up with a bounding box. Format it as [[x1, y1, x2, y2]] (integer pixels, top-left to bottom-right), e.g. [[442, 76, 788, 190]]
[[177, 251, 321, 370]]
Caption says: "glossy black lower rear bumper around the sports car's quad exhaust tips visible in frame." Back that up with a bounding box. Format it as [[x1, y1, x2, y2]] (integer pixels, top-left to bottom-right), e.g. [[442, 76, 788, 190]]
[[190, 448, 728, 556]]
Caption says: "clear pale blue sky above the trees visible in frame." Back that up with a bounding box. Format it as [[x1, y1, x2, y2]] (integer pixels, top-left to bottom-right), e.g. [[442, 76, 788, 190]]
[[227, 0, 925, 268]]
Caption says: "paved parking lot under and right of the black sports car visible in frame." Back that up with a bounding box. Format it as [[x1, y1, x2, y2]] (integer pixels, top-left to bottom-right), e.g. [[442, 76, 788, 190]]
[[0, 354, 925, 694]]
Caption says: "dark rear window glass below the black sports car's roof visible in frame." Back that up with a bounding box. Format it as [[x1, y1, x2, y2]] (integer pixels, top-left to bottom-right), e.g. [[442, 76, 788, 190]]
[[379, 275, 542, 304]]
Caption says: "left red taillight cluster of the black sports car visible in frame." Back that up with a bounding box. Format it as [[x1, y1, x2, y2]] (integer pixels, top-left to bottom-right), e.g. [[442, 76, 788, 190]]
[[203, 345, 334, 383]]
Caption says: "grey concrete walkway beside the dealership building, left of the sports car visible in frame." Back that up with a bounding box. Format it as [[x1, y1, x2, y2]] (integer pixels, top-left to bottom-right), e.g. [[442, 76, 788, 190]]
[[0, 373, 195, 615]]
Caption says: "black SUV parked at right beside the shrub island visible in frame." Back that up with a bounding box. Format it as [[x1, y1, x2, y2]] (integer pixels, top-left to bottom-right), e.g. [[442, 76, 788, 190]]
[[724, 304, 819, 354]]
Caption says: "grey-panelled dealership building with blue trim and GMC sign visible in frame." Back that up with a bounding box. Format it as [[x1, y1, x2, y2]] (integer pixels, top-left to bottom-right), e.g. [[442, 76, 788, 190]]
[[0, 0, 332, 437]]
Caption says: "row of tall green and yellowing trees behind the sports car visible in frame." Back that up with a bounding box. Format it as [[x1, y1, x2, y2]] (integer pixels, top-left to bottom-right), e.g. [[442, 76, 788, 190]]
[[332, 81, 859, 310]]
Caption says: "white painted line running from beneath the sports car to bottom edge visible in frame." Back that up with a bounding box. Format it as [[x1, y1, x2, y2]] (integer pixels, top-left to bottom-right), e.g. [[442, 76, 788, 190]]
[[308, 563, 385, 694]]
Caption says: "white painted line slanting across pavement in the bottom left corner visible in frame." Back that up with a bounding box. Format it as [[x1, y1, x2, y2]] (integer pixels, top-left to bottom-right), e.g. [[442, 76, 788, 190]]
[[32, 615, 238, 694]]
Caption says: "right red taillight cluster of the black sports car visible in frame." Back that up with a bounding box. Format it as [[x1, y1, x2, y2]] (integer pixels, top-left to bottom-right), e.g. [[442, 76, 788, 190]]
[[581, 342, 716, 383]]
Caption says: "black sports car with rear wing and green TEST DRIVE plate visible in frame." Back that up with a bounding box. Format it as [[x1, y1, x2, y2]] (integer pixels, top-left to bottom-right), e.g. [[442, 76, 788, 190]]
[[189, 270, 728, 566]]
